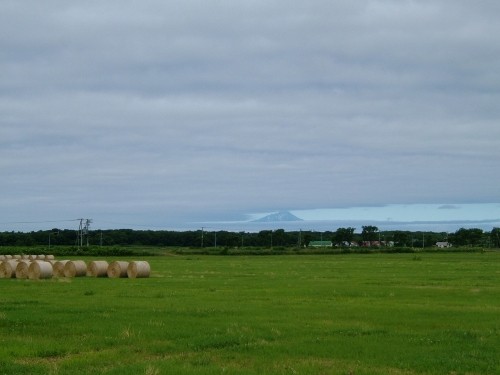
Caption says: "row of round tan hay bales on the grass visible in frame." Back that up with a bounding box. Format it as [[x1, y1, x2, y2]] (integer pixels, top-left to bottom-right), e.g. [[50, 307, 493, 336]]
[[0, 257, 151, 280]]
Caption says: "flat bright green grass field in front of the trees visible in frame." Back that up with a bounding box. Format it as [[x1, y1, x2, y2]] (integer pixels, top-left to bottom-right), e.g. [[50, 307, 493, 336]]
[[0, 252, 500, 375]]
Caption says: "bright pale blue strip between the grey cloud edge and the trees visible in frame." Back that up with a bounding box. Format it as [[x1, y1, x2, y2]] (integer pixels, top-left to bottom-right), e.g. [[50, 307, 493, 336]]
[[200, 203, 500, 232]]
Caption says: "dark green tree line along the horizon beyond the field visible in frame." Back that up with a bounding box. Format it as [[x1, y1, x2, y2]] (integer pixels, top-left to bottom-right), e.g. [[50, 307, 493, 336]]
[[0, 225, 500, 248]]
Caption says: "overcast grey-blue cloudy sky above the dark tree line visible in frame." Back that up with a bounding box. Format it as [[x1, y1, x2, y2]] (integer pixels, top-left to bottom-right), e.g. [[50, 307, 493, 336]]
[[0, 0, 500, 231]]
